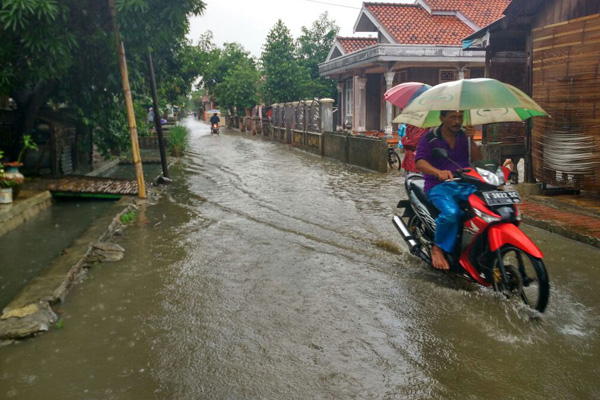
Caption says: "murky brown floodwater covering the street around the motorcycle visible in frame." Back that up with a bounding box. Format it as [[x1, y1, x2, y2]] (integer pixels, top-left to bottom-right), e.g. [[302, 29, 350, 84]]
[[0, 120, 600, 399]]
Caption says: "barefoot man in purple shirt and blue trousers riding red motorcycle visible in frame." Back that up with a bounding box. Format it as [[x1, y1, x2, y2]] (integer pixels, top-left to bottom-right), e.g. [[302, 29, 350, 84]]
[[415, 111, 481, 269]]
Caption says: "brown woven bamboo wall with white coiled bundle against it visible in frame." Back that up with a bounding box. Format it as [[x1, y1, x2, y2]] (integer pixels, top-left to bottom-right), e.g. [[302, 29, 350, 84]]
[[532, 10, 600, 191]]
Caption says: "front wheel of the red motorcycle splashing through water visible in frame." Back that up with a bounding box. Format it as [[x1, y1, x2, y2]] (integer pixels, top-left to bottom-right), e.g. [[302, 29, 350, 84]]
[[494, 246, 550, 312]]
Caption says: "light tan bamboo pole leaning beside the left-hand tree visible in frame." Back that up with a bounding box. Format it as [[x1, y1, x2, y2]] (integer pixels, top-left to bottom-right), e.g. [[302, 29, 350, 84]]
[[108, 0, 146, 199]]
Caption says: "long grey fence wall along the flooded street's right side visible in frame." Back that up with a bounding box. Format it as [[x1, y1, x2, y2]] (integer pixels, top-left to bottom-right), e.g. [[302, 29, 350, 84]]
[[226, 99, 388, 172]]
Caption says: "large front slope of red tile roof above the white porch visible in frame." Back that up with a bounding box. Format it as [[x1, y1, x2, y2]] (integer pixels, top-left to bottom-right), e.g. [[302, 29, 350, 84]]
[[364, 3, 473, 46]]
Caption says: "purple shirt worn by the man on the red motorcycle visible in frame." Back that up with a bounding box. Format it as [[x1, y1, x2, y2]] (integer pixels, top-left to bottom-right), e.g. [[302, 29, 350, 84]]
[[415, 126, 469, 193]]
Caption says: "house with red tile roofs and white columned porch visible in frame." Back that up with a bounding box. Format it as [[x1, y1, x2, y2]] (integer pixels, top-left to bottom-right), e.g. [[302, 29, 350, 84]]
[[319, 0, 511, 134]]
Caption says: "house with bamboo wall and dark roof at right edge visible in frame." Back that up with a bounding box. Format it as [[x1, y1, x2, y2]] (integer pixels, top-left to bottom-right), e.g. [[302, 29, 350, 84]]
[[465, 0, 600, 191]]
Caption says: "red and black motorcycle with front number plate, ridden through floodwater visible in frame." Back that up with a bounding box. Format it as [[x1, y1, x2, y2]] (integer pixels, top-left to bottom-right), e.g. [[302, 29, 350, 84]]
[[393, 149, 550, 312]]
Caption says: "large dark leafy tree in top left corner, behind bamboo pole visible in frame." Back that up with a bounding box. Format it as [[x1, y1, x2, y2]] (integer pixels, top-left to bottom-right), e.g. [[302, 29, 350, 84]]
[[0, 0, 204, 159]]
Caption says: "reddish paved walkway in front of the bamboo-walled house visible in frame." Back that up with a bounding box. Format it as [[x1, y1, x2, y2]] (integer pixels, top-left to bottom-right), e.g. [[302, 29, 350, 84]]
[[521, 190, 600, 248]]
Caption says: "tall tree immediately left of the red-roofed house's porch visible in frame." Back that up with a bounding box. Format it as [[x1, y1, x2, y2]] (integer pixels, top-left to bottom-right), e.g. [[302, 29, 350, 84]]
[[298, 12, 340, 98]]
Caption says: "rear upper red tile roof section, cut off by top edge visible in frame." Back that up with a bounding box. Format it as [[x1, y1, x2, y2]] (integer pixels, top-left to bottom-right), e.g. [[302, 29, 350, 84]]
[[423, 0, 511, 28]]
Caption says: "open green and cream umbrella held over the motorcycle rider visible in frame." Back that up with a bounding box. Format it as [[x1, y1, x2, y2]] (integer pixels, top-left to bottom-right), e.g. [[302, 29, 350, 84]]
[[392, 78, 548, 128]]
